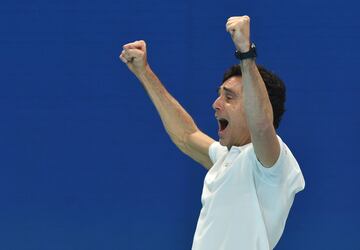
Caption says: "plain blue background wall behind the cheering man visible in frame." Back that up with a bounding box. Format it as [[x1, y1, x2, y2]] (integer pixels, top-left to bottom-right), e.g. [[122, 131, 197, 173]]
[[0, 0, 360, 250]]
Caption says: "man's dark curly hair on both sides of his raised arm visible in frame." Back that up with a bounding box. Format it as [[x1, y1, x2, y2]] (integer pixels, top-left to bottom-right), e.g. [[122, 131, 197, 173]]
[[223, 65, 286, 129]]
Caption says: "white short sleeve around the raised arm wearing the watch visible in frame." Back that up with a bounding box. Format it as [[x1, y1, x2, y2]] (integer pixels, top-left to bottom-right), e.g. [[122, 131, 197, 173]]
[[254, 136, 305, 193]]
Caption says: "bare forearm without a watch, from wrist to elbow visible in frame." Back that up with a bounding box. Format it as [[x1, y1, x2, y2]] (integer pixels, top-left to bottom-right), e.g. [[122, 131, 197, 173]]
[[136, 66, 198, 149]]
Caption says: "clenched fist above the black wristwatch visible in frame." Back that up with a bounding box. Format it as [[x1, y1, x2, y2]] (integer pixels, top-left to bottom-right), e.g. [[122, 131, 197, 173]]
[[226, 16, 250, 52]]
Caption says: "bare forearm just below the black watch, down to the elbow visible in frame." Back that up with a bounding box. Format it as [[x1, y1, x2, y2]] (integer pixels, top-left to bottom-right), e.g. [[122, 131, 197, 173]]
[[240, 59, 273, 135]]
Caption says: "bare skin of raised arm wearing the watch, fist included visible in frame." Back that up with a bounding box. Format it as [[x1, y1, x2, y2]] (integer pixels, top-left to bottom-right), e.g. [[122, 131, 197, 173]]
[[226, 16, 280, 167]]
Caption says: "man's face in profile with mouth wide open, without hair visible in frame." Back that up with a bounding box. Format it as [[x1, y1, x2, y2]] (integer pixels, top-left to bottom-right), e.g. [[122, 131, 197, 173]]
[[213, 76, 250, 149]]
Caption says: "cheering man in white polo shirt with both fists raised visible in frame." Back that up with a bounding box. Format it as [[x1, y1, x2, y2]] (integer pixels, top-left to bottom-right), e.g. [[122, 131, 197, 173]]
[[120, 16, 305, 250]]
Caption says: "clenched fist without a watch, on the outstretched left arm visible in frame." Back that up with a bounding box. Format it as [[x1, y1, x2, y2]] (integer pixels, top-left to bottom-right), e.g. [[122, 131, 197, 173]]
[[119, 40, 148, 75]]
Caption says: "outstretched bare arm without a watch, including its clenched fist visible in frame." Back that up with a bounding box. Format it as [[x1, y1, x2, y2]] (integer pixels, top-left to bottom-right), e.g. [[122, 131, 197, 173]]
[[120, 41, 214, 169]]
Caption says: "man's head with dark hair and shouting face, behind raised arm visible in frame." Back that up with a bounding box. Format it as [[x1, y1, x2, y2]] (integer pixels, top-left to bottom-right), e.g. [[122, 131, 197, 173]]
[[213, 65, 286, 146]]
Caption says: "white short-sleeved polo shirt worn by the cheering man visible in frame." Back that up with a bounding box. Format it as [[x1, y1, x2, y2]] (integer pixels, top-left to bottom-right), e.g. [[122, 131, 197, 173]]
[[192, 136, 305, 250]]
